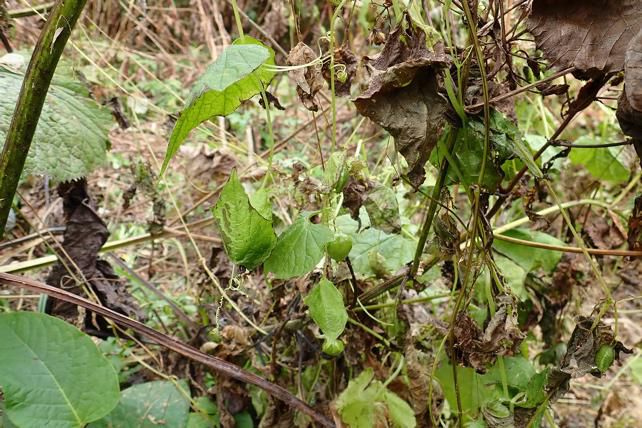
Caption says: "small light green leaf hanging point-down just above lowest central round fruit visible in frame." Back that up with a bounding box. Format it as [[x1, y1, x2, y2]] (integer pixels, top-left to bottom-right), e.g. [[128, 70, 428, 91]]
[[305, 278, 348, 339]]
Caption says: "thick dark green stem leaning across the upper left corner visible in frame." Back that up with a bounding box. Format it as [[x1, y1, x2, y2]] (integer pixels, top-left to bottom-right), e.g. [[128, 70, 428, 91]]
[[0, 0, 87, 238]]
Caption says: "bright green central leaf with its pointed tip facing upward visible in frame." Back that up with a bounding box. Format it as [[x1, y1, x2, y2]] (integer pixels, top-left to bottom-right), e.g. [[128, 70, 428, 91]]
[[213, 171, 276, 269]]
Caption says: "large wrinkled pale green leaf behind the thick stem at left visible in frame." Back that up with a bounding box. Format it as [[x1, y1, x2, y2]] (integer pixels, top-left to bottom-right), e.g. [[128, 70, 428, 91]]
[[0, 67, 112, 181]]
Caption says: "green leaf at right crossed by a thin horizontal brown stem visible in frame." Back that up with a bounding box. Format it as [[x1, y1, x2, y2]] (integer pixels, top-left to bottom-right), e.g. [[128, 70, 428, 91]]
[[493, 229, 565, 273]]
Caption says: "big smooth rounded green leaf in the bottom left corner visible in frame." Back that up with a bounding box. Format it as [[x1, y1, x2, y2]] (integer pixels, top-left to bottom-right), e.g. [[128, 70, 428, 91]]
[[0, 312, 119, 428]]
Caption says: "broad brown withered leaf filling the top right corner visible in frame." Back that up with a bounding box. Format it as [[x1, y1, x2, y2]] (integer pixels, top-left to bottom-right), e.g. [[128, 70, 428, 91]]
[[528, 0, 642, 77]]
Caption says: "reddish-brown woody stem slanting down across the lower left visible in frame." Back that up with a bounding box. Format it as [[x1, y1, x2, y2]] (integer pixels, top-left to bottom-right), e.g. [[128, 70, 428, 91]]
[[0, 273, 335, 427]]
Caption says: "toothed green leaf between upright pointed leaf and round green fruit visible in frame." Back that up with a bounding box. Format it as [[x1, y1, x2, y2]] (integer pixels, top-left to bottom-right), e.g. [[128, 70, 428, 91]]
[[265, 215, 333, 279]]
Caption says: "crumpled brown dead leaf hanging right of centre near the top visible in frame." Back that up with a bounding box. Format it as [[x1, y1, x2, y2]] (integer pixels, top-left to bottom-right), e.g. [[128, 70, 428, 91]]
[[354, 18, 448, 186]]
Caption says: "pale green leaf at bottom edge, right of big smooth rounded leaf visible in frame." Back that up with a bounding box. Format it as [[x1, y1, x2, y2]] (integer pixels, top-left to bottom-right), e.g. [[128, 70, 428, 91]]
[[91, 381, 190, 428]]
